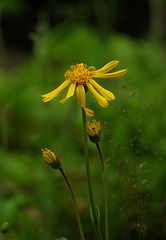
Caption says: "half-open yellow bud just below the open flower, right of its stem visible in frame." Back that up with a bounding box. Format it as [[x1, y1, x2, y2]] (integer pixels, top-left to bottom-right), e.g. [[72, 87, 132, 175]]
[[86, 119, 101, 143]]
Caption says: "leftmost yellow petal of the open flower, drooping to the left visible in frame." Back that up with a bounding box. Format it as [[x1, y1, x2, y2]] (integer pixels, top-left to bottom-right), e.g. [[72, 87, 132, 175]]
[[41, 80, 71, 102]]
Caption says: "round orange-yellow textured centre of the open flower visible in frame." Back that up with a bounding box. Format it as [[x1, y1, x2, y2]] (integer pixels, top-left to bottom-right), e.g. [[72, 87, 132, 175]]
[[65, 63, 95, 85]]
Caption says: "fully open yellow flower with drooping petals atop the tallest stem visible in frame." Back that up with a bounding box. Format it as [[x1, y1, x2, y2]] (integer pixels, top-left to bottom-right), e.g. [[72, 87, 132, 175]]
[[42, 60, 127, 117]]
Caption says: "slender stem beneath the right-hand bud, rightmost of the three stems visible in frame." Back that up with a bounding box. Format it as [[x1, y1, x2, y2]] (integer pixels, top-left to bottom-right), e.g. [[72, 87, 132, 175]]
[[96, 143, 109, 240]]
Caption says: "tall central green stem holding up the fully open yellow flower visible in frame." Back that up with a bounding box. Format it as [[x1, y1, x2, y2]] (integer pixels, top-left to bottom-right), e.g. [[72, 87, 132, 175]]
[[82, 108, 102, 240]]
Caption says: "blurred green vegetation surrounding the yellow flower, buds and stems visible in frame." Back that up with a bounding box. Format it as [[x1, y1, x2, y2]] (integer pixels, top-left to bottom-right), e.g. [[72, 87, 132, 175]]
[[0, 0, 166, 240]]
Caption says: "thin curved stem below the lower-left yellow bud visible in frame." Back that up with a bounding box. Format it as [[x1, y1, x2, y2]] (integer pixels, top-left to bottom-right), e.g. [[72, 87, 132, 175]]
[[59, 168, 85, 240]]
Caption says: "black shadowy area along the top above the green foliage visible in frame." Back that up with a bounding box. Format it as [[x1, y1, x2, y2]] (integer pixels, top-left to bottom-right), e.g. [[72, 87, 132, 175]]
[[1, 0, 152, 52]]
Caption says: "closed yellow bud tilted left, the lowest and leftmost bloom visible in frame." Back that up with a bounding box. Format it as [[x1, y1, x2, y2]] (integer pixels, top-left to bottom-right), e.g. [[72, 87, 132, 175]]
[[41, 148, 62, 169]]
